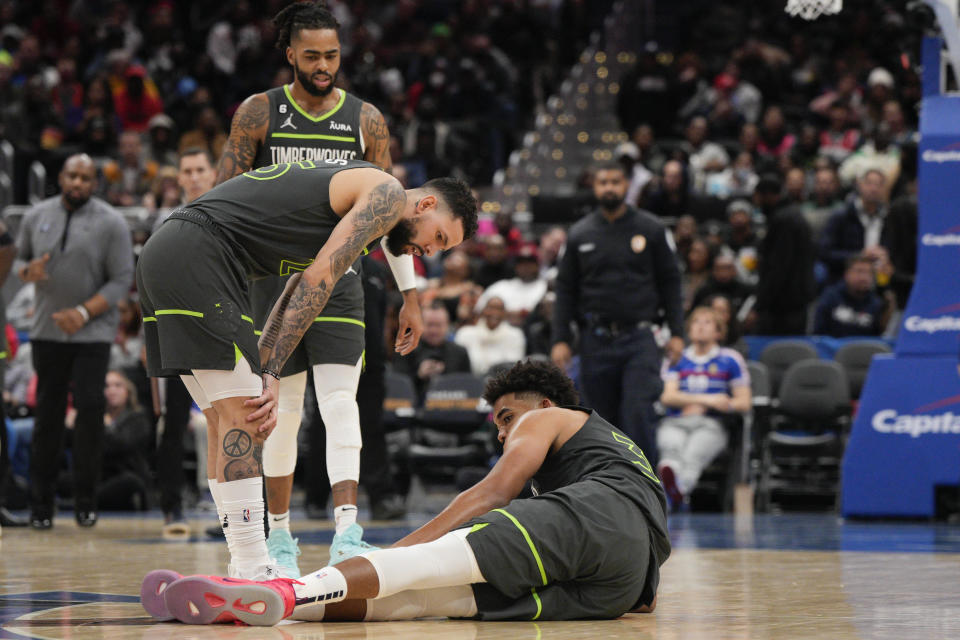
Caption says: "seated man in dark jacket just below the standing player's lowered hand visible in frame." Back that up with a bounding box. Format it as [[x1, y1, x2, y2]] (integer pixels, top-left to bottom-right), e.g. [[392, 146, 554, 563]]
[[396, 302, 470, 398]]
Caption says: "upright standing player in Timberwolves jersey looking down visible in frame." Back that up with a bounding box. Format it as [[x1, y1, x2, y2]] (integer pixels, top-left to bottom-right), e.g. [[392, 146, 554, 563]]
[[208, 2, 422, 577]]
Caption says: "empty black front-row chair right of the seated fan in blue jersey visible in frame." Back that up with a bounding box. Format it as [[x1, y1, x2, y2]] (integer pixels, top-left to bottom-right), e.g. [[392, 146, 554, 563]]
[[757, 360, 850, 511]]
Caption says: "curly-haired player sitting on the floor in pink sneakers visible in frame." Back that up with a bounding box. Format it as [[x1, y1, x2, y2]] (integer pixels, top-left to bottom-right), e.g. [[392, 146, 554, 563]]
[[141, 362, 670, 625]]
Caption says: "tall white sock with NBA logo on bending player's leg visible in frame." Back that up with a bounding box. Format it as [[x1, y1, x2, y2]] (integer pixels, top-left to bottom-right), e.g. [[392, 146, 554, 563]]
[[217, 476, 270, 573]]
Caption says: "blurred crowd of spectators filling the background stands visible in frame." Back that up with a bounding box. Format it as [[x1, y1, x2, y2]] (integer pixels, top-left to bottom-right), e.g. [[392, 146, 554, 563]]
[[0, 0, 920, 512]]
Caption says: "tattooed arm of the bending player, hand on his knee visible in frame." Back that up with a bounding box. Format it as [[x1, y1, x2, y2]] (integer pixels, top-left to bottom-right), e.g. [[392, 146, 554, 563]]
[[263, 178, 406, 371]]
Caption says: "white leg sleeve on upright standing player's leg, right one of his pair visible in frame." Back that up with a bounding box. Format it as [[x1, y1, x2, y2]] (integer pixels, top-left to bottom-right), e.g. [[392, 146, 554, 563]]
[[313, 360, 362, 486]]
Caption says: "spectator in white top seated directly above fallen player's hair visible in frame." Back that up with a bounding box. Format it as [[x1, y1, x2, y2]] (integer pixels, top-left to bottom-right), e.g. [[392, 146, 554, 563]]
[[454, 296, 526, 376]]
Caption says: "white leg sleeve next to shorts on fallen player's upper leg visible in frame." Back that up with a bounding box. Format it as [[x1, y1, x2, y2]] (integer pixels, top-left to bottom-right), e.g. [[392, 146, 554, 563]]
[[360, 529, 486, 600]]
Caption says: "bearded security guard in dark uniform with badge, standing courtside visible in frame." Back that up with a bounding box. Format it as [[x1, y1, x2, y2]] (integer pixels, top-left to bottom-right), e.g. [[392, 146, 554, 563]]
[[551, 163, 683, 465]]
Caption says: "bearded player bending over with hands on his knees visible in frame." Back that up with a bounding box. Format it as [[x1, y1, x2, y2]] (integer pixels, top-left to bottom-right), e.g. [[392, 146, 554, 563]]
[[137, 160, 477, 580]]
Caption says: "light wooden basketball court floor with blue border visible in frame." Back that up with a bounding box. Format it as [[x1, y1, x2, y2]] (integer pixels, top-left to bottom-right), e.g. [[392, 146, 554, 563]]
[[0, 513, 960, 640]]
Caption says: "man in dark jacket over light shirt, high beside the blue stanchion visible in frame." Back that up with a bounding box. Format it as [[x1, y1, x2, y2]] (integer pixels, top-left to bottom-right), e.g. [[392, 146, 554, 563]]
[[820, 169, 888, 283]]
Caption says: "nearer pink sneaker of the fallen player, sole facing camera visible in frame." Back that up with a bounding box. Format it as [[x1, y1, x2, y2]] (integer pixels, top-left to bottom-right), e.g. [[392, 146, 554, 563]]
[[163, 576, 302, 627]]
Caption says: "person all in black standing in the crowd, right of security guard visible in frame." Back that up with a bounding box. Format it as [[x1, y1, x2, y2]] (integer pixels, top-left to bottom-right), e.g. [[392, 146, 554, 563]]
[[753, 176, 816, 335]]
